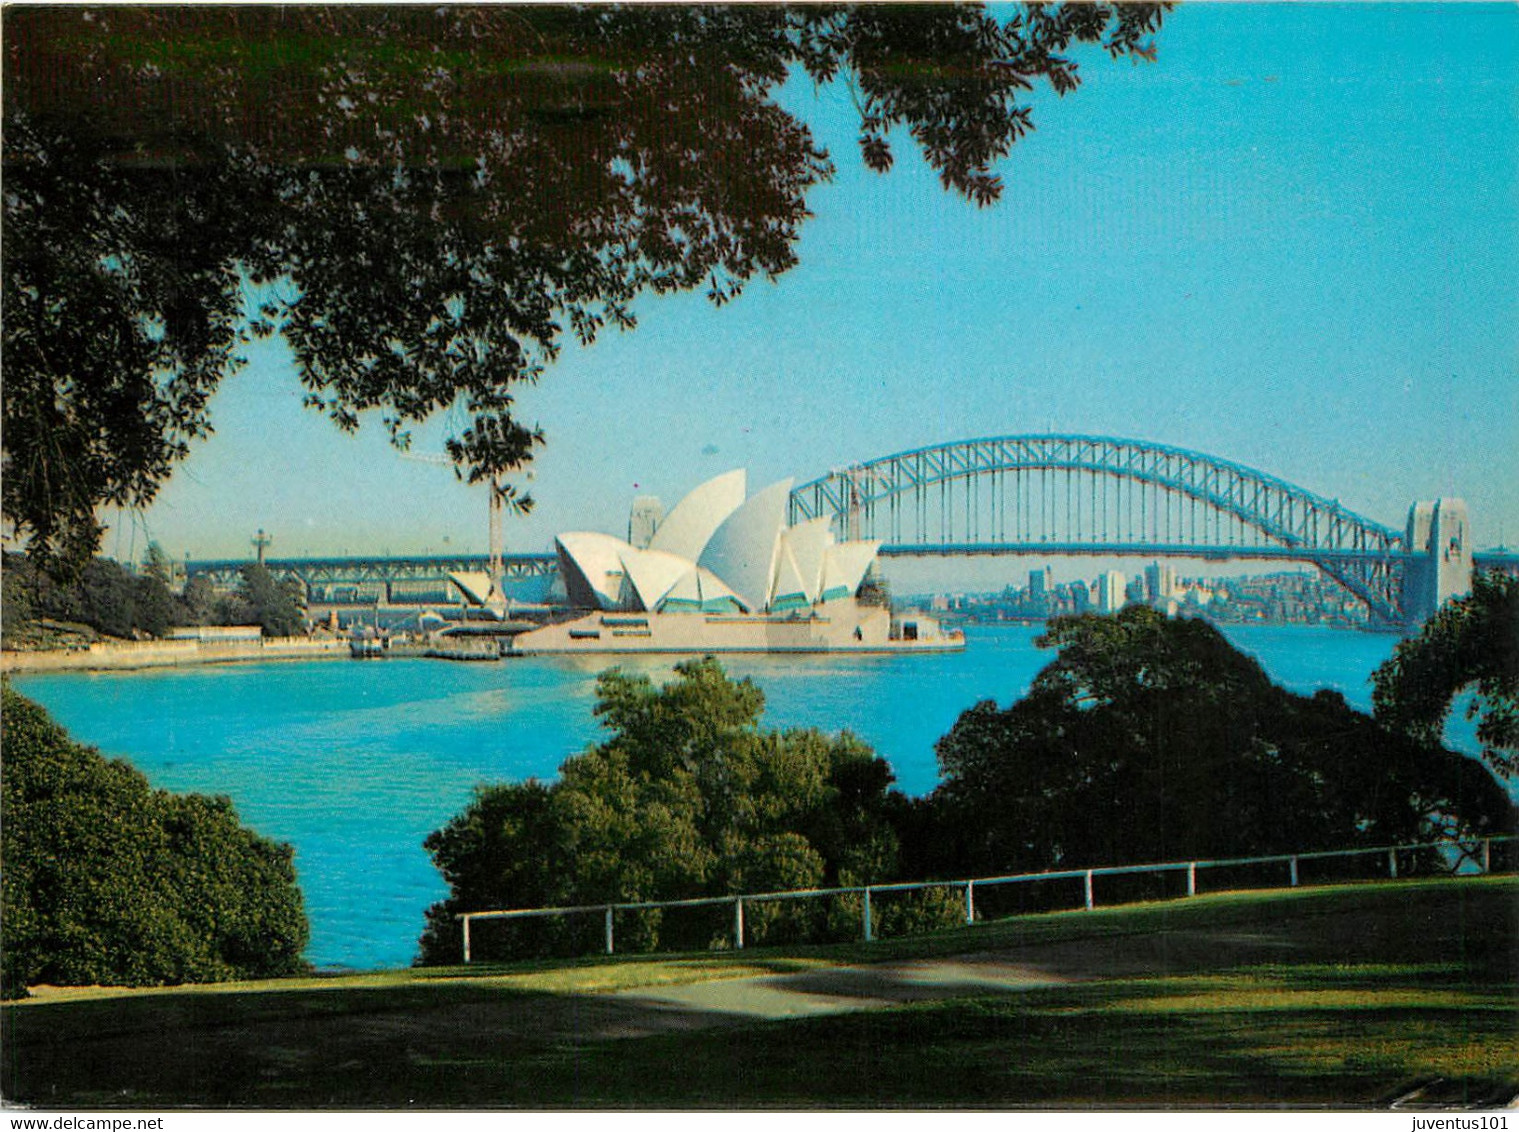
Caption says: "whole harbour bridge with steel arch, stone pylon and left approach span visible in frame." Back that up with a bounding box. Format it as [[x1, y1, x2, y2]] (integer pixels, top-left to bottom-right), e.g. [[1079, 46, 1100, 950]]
[[188, 435, 1519, 624]]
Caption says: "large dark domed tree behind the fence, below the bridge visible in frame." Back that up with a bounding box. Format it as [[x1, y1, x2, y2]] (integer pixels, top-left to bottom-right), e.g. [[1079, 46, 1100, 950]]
[[911, 606, 1514, 875]]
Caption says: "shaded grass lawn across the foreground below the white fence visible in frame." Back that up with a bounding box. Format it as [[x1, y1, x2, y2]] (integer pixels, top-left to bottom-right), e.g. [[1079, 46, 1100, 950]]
[[0, 877, 1519, 1109]]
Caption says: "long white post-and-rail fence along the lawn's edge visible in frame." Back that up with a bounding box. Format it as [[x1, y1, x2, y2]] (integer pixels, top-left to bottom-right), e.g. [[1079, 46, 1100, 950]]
[[454, 834, 1516, 963]]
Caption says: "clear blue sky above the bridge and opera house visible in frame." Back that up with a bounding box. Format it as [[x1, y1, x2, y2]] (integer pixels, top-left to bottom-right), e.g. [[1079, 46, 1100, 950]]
[[118, 3, 1519, 592]]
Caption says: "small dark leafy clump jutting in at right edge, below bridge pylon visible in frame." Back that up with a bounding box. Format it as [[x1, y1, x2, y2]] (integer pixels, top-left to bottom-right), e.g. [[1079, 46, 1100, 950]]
[[1372, 573, 1519, 776]]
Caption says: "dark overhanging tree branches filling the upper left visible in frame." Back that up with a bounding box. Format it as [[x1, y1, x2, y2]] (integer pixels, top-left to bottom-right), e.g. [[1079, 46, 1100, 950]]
[[3, 3, 1164, 570]]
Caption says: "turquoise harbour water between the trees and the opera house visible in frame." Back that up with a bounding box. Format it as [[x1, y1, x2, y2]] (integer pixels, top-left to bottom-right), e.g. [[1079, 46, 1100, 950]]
[[5, 626, 1396, 968]]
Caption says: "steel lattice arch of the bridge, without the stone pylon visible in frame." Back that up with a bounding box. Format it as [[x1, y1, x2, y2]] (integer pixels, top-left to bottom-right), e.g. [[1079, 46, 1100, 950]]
[[790, 435, 1410, 623]]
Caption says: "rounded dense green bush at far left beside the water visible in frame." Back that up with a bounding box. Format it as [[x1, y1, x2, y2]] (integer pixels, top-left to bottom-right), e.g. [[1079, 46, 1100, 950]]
[[0, 685, 307, 997]]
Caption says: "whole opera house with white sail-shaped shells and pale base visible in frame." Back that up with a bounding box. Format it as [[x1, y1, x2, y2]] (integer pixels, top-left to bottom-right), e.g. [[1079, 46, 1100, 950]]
[[512, 470, 965, 653]]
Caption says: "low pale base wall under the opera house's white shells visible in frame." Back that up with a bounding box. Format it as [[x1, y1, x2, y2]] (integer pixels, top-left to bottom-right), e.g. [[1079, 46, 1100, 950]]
[[510, 600, 965, 656]]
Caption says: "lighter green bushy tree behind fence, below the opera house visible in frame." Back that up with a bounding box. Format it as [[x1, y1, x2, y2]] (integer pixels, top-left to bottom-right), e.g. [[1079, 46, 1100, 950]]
[[422, 658, 917, 963]]
